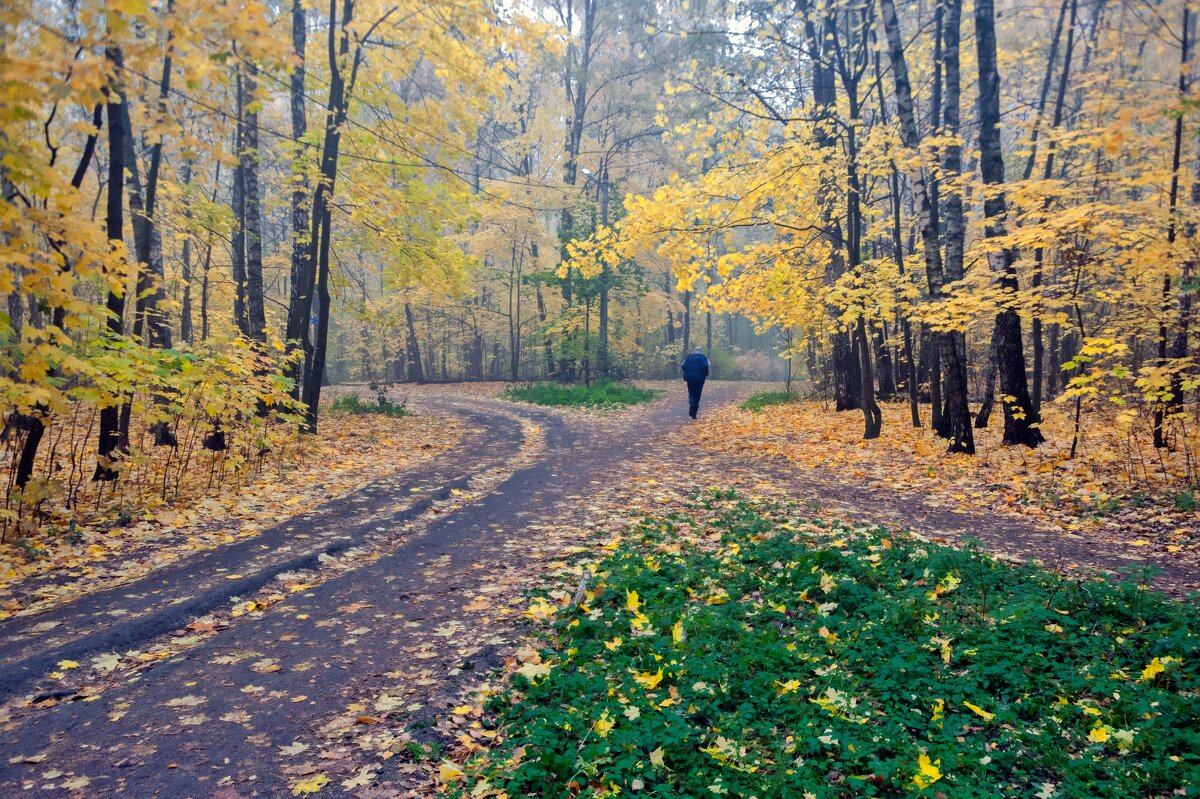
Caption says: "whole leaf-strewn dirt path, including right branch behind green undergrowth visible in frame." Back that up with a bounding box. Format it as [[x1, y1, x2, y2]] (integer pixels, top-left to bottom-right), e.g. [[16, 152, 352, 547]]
[[0, 383, 1196, 799]]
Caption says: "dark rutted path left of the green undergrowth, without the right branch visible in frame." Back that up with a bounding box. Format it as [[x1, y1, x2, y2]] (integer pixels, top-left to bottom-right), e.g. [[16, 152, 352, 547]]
[[0, 385, 744, 799]]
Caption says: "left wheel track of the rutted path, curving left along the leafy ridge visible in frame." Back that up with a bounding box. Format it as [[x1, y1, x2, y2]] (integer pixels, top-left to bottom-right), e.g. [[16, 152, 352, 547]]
[[0, 402, 522, 703]]
